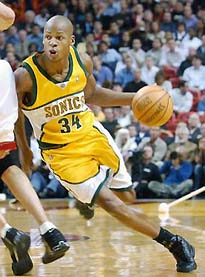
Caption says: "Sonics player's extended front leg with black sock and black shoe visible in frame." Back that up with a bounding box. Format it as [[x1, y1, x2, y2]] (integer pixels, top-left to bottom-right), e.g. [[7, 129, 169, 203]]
[[96, 186, 197, 272]]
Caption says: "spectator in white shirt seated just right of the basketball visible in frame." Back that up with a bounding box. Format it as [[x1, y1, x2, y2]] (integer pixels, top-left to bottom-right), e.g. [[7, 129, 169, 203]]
[[170, 80, 193, 113]]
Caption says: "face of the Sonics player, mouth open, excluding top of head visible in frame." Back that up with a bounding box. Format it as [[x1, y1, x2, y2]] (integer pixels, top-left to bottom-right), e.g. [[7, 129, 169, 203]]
[[43, 24, 74, 62]]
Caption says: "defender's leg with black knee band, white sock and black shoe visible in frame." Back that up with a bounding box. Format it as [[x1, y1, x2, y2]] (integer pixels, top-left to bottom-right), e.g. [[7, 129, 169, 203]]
[[0, 154, 69, 263]]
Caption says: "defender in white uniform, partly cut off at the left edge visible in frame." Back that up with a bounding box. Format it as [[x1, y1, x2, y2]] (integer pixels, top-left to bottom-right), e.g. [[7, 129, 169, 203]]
[[0, 3, 69, 275]]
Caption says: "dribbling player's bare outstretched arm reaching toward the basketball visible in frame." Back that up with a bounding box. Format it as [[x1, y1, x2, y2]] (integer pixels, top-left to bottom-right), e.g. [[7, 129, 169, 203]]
[[81, 53, 135, 107]]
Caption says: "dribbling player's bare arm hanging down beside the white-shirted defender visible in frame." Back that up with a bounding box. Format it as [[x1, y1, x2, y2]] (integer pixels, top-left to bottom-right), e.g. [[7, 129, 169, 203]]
[[14, 67, 33, 174]]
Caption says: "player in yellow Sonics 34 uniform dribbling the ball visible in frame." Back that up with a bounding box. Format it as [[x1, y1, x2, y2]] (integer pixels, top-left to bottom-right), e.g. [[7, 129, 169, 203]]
[[15, 16, 196, 272]]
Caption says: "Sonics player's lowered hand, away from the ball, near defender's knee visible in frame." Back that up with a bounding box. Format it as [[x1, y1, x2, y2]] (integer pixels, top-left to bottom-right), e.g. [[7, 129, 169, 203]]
[[19, 148, 33, 176]]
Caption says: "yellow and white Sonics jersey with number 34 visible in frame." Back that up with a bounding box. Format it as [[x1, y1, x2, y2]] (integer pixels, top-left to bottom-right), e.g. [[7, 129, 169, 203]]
[[22, 47, 94, 149]]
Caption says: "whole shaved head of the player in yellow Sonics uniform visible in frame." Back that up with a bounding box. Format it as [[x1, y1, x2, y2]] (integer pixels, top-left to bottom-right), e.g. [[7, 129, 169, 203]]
[[43, 15, 75, 61]]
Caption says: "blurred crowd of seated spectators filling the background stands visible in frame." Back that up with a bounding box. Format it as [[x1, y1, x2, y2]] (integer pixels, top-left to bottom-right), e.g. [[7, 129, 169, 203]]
[[0, 0, 205, 198]]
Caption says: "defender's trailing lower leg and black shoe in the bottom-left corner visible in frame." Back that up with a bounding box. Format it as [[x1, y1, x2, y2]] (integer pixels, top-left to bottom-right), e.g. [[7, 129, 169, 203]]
[[0, 211, 33, 275]]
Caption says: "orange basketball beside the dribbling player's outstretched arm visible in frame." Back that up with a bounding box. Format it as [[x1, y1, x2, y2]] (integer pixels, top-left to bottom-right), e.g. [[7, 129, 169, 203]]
[[132, 85, 173, 127]]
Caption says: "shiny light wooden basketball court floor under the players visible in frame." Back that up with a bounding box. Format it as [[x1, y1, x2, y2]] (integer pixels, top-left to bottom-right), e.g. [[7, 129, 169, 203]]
[[0, 199, 205, 277]]
